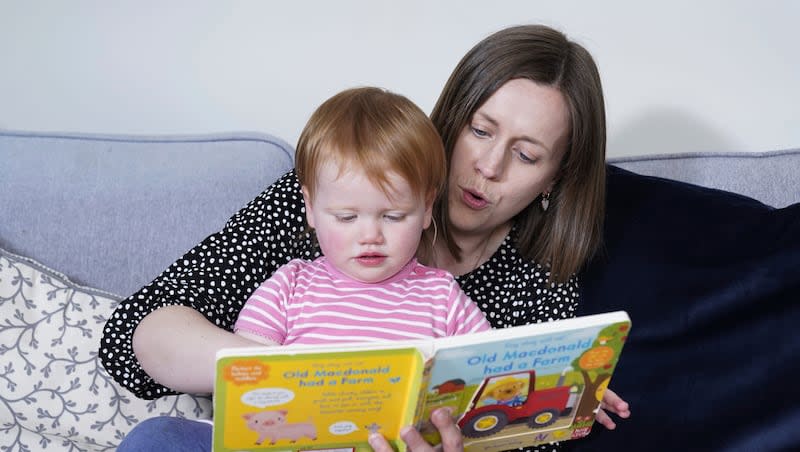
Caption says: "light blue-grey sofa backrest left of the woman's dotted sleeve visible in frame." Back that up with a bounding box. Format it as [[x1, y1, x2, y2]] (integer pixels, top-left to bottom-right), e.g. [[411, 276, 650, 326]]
[[0, 131, 294, 296]]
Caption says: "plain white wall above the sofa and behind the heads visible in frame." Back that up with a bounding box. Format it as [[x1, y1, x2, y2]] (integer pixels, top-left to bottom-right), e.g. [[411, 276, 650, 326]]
[[0, 0, 800, 156]]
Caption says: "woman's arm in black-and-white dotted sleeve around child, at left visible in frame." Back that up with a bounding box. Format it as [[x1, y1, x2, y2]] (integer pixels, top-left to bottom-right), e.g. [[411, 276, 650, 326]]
[[99, 172, 318, 399]]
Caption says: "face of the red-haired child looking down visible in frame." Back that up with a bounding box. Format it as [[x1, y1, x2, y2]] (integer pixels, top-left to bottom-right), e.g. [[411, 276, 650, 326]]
[[303, 162, 431, 283]]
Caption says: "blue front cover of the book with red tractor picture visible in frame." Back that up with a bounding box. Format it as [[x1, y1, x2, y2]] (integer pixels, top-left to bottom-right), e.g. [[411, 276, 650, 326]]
[[417, 316, 630, 451]]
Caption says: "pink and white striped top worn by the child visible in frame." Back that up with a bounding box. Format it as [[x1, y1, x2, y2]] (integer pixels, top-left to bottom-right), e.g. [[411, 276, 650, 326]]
[[234, 256, 490, 345]]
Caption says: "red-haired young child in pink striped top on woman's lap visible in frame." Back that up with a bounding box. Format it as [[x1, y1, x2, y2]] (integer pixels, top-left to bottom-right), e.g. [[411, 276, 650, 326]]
[[234, 88, 490, 345]]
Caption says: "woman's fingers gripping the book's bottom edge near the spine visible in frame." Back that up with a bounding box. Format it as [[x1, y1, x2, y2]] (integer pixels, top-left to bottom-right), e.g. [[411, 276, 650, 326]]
[[369, 408, 464, 452]]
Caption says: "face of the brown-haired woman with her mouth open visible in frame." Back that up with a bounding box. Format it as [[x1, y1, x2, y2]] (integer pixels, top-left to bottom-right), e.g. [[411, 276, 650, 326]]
[[448, 79, 570, 236]]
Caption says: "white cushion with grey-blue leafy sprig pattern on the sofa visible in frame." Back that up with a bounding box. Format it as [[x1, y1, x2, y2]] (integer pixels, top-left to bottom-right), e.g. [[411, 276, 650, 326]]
[[0, 248, 211, 451]]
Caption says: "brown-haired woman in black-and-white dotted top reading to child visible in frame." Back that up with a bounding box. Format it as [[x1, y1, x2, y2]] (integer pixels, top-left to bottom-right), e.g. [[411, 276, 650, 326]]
[[108, 25, 629, 452]]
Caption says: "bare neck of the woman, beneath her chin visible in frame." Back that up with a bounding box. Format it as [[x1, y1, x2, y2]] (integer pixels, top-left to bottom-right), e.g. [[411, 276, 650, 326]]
[[432, 223, 511, 276]]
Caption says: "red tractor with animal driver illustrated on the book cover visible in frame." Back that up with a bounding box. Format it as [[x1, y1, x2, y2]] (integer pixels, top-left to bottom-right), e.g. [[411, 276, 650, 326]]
[[458, 368, 578, 438]]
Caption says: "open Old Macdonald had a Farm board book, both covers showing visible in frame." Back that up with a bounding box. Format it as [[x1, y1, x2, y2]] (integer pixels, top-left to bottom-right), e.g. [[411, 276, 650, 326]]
[[213, 311, 631, 452]]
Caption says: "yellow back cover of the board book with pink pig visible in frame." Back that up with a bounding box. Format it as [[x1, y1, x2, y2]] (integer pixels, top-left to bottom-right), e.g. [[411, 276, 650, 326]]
[[214, 348, 422, 451]]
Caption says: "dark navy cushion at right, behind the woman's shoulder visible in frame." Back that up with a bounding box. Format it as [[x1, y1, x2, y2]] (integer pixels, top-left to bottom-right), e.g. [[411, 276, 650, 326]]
[[574, 166, 800, 450]]
